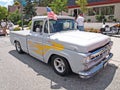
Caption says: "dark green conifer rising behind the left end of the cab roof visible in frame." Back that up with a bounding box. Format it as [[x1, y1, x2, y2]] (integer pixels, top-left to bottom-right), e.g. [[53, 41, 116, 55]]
[[23, 0, 36, 19]]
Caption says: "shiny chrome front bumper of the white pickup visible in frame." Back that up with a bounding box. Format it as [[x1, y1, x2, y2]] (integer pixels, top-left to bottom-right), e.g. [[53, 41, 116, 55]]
[[79, 53, 113, 79]]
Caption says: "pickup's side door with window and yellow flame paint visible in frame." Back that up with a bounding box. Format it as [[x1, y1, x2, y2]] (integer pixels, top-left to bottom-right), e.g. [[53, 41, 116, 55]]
[[27, 20, 44, 60]]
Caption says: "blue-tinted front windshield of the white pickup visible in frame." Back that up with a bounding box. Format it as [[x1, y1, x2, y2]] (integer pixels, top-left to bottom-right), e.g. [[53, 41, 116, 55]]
[[49, 19, 77, 33]]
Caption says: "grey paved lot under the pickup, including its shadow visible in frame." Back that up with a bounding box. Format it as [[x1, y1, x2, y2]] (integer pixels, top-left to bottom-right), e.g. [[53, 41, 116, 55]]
[[0, 36, 120, 90]]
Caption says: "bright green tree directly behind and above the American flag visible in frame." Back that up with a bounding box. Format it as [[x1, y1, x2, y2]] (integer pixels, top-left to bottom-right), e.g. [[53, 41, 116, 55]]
[[49, 0, 68, 14]]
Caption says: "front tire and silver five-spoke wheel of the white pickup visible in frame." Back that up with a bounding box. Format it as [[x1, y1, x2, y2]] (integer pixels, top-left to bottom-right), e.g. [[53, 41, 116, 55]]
[[51, 55, 71, 76]]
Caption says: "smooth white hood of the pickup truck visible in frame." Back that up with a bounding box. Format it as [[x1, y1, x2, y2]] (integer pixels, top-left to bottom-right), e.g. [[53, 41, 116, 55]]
[[50, 30, 110, 53]]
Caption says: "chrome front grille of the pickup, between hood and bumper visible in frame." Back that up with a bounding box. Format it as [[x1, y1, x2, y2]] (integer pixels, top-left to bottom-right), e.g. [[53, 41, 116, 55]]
[[85, 41, 112, 70]]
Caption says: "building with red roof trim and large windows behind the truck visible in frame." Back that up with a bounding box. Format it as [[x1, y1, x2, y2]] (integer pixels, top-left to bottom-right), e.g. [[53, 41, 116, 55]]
[[68, 0, 120, 21]]
